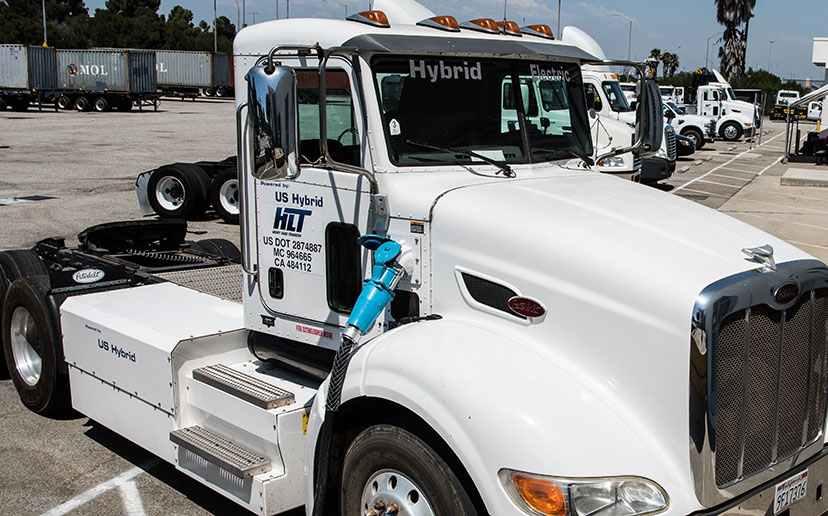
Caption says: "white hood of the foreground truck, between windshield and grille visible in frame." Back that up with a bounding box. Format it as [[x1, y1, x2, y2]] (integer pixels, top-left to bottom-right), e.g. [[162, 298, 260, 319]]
[[430, 174, 809, 484]]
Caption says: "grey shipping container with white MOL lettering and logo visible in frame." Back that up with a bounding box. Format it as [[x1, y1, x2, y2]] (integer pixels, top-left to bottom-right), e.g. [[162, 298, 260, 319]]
[[57, 50, 129, 92]]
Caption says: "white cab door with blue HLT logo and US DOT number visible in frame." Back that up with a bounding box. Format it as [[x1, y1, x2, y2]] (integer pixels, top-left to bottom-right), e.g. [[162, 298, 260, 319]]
[[256, 58, 371, 328]]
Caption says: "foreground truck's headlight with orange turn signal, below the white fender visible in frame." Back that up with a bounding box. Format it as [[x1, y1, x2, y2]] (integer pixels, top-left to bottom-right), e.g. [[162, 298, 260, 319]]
[[499, 469, 669, 516]]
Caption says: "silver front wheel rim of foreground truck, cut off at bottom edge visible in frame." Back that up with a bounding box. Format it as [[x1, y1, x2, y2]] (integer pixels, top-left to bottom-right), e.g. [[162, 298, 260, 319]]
[[361, 469, 434, 516]]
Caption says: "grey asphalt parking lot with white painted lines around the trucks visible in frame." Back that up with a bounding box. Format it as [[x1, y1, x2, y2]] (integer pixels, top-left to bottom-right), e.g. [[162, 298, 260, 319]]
[[0, 100, 828, 516]]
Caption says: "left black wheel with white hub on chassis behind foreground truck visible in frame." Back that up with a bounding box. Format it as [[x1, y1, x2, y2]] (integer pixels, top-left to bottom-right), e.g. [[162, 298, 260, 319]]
[[147, 163, 209, 219]]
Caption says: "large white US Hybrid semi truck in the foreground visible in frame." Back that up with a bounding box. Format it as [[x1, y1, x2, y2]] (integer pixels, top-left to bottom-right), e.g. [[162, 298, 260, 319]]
[[0, 1, 828, 516]]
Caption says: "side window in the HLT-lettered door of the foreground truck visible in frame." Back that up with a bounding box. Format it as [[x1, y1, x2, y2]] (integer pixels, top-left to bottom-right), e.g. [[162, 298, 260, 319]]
[[296, 70, 361, 166]]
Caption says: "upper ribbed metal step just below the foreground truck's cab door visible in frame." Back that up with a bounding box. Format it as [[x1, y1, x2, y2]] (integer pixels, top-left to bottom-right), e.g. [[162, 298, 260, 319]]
[[193, 364, 295, 410]]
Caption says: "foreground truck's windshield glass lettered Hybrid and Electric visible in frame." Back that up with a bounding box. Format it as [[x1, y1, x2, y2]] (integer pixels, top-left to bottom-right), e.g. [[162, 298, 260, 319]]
[[371, 56, 592, 166]]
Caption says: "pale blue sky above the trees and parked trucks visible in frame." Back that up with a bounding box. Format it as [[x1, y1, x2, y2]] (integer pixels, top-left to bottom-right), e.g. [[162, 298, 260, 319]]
[[86, 0, 828, 80]]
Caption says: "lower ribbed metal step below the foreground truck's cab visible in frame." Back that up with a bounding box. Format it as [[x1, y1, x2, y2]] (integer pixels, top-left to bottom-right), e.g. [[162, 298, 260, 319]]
[[170, 426, 271, 478]]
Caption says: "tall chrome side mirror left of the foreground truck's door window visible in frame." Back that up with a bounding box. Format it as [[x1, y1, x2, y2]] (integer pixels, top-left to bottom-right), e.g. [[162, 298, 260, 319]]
[[246, 66, 299, 181]]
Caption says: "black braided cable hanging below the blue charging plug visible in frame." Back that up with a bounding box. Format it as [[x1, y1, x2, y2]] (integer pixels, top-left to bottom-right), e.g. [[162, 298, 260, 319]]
[[313, 335, 356, 516]]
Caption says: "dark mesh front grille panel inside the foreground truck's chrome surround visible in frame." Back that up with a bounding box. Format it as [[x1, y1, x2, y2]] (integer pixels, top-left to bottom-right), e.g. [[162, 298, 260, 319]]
[[711, 289, 828, 488]]
